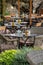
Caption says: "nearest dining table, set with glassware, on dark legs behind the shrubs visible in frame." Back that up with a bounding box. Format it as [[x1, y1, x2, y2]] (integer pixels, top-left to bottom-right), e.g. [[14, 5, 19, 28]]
[[1, 33, 37, 48]]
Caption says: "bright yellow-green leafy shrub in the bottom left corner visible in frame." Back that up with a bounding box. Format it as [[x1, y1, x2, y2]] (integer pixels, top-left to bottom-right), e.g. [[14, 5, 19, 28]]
[[0, 50, 17, 65]]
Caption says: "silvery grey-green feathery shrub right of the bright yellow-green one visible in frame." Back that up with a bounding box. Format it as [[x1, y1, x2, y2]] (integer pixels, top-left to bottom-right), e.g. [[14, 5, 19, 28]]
[[11, 48, 29, 65]]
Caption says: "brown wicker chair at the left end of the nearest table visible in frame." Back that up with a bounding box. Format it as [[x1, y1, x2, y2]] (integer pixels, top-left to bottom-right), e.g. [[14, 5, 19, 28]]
[[0, 34, 17, 51]]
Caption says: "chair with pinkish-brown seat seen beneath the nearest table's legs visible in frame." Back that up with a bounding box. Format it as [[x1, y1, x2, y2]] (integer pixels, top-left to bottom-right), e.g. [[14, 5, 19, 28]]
[[19, 38, 34, 48]]
